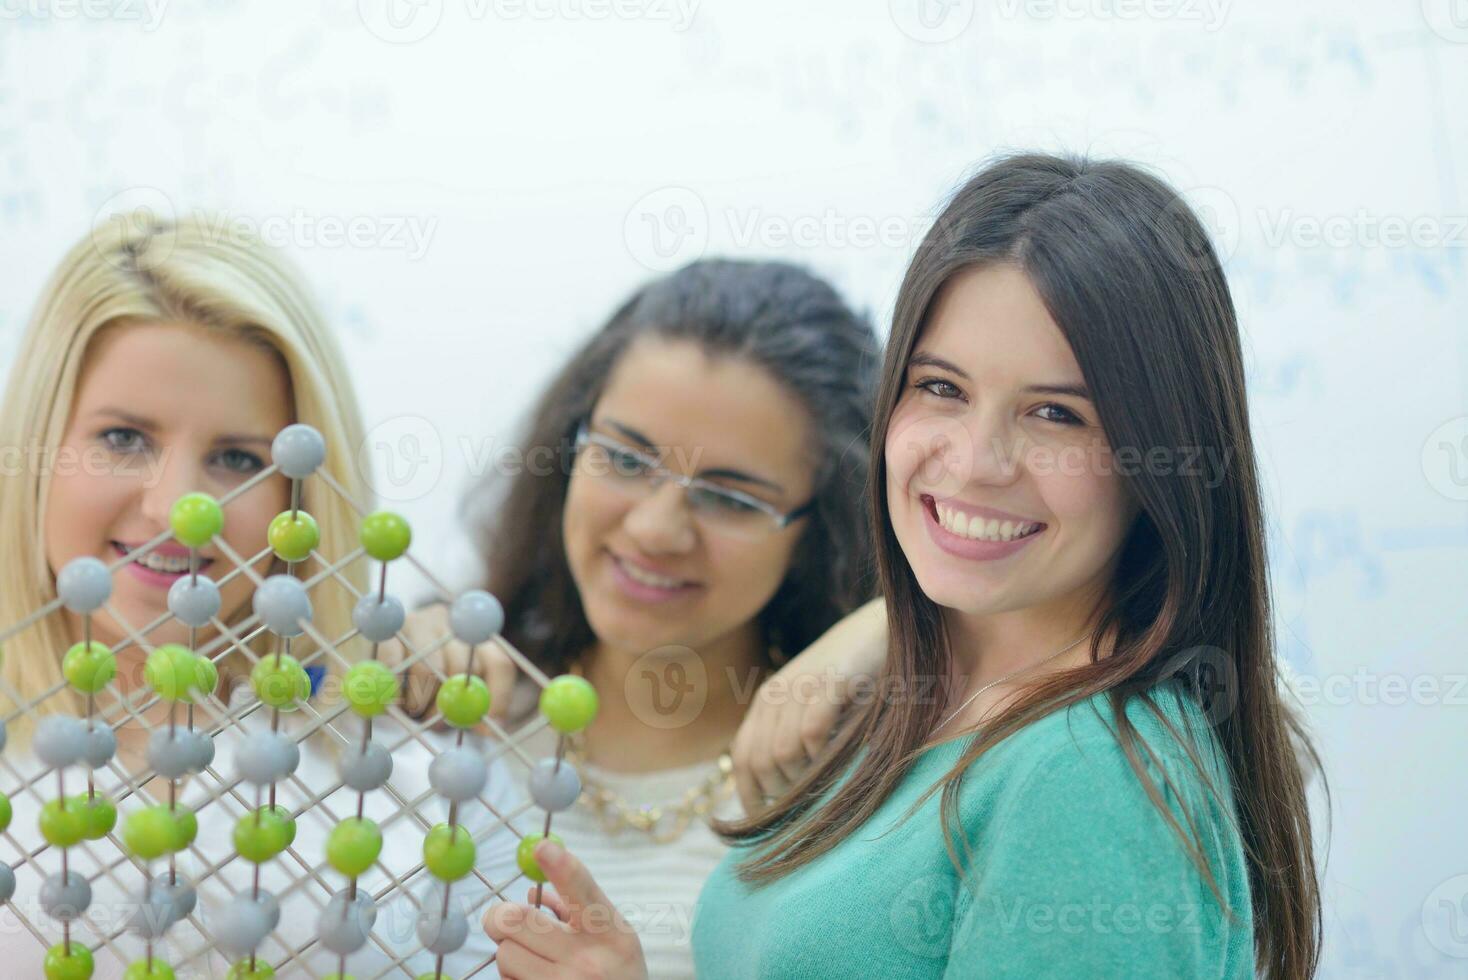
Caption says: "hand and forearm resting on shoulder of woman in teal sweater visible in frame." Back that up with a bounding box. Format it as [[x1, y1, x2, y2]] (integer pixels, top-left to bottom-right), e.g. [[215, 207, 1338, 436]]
[[730, 599, 887, 816]]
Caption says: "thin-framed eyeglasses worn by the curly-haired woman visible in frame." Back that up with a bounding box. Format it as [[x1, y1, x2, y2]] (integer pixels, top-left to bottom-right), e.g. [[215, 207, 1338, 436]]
[[575, 421, 815, 538]]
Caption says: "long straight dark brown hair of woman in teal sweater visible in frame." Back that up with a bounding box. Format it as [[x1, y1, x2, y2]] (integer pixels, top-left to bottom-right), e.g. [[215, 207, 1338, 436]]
[[721, 154, 1321, 977]]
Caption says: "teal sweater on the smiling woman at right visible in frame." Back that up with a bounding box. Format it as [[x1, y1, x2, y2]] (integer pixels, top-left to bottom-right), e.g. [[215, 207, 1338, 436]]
[[693, 691, 1254, 980]]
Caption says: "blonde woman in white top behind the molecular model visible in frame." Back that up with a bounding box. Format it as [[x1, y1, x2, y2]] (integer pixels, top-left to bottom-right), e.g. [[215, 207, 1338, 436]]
[[0, 219, 522, 977]]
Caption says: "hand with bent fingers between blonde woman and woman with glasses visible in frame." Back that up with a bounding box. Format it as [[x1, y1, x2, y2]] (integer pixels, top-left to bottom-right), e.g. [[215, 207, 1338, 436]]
[[377, 603, 517, 728]]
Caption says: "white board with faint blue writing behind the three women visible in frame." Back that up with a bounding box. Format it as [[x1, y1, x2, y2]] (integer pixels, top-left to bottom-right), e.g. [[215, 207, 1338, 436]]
[[0, 0, 1468, 977]]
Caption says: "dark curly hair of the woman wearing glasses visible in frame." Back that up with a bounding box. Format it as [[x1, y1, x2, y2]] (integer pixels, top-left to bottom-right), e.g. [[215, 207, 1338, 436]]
[[467, 260, 879, 692]]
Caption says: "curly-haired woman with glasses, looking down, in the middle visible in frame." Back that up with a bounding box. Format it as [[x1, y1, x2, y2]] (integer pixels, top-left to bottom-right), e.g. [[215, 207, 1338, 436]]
[[384, 261, 879, 977]]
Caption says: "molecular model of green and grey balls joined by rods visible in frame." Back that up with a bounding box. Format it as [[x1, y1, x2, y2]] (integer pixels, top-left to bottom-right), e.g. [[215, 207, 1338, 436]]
[[0, 425, 597, 980]]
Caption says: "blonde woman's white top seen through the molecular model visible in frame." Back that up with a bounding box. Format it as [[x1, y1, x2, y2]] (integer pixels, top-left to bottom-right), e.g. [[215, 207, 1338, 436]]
[[0, 685, 517, 980]]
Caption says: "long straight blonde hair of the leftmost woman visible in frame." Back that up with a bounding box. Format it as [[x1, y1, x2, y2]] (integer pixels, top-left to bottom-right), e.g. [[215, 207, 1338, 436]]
[[0, 216, 371, 741]]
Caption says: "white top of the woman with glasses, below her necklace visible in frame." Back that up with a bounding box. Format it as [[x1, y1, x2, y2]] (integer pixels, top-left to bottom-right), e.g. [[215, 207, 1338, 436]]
[[464, 722, 744, 980]]
